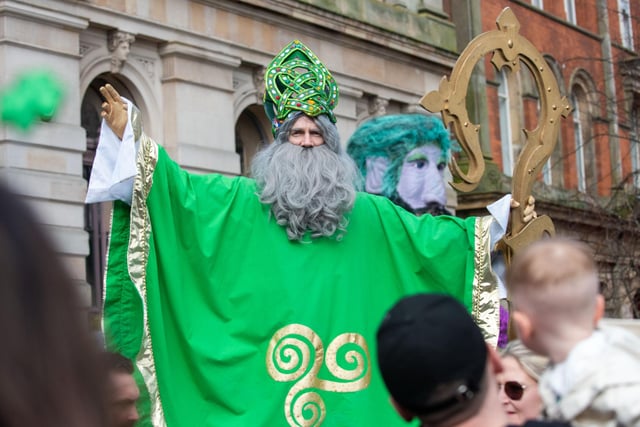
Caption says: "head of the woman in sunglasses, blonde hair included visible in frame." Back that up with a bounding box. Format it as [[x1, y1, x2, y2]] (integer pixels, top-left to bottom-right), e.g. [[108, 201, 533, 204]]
[[498, 340, 549, 425]]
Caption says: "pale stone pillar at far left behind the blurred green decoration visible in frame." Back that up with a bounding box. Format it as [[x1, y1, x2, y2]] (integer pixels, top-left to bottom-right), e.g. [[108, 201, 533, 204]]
[[0, 1, 91, 306]]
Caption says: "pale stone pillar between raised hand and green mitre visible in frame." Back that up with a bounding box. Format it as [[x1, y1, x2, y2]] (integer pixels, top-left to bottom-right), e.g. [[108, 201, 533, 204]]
[[159, 42, 241, 174]]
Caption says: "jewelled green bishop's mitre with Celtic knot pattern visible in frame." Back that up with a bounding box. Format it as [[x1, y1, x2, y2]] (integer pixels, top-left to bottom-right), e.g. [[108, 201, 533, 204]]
[[264, 40, 338, 135]]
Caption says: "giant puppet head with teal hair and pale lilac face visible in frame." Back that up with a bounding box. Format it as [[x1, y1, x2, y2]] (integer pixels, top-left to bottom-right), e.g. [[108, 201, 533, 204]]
[[347, 113, 451, 215]]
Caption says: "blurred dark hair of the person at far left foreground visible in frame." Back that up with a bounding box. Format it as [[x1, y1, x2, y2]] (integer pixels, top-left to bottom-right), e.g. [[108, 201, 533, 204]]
[[0, 183, 105, 427]]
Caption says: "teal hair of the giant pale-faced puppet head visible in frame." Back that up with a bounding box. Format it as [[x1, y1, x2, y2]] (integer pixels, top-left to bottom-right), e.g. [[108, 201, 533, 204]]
[[347, 113, 452, 198]]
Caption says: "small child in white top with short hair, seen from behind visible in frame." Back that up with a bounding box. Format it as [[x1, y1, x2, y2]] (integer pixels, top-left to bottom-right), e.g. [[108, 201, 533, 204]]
[[507, 238, 640, 427]]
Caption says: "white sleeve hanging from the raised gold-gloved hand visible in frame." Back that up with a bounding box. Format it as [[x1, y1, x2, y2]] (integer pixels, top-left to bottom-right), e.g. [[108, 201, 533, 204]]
[[85, 100, 139, 204]]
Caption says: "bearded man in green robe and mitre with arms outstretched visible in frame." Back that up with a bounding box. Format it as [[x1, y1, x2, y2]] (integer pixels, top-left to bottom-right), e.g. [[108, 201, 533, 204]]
[[87, 41, 532, 427]]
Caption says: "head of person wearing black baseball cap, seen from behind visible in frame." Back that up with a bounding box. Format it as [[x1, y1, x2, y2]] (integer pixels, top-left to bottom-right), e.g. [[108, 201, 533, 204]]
[[377, 294, 507, 427]]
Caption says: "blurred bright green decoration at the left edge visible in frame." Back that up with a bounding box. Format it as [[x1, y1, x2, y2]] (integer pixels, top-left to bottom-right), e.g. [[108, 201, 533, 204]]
[[0, 71, 63, 130]]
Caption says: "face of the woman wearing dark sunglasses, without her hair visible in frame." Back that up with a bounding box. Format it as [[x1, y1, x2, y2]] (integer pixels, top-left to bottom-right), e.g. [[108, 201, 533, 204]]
[[498, 356, 542, 424]]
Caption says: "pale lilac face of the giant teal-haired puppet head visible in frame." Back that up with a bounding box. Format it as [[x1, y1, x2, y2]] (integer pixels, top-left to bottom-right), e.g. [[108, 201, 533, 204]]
[[397, 145, 447, 210]]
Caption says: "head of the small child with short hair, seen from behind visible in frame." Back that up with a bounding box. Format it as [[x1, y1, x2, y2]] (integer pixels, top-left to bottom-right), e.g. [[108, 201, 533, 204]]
[[507, 238, 604, 363]]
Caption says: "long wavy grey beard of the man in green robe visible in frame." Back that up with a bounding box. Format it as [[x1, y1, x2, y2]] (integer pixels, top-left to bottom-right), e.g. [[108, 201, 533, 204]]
[[252, 143, 359, 240]]
